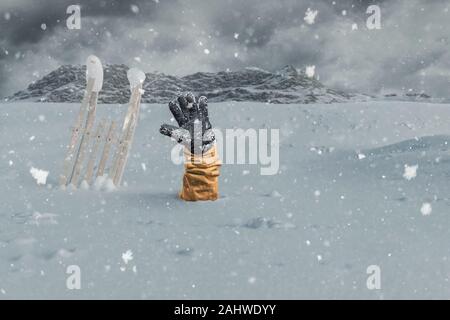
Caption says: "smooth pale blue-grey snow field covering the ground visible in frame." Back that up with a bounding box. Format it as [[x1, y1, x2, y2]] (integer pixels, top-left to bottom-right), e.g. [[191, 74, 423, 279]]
[[0, 102, 450, 299]]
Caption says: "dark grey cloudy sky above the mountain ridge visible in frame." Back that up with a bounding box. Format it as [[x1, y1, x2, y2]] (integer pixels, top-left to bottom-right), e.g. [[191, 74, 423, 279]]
[[0, 0, 450, 97]]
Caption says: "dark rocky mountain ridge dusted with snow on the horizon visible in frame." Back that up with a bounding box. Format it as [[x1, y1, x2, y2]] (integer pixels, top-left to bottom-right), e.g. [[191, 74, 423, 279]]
[[7, 64, 367, 103]]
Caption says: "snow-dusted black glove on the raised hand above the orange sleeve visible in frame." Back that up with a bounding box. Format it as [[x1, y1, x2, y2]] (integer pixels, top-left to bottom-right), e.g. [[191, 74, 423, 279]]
[[159, 93, 215, 155]]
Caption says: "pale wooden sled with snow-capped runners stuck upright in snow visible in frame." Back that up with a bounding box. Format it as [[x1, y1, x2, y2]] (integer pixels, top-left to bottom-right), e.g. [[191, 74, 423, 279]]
[[59, 56, 145, 188]]
